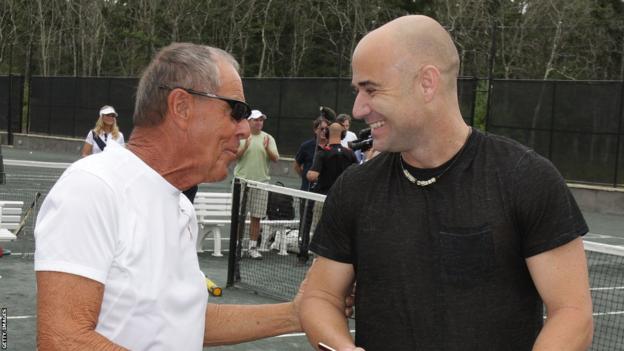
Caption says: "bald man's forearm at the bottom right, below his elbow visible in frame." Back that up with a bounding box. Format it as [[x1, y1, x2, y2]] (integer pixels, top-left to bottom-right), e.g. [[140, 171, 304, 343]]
[[533, 308, 593, 351]]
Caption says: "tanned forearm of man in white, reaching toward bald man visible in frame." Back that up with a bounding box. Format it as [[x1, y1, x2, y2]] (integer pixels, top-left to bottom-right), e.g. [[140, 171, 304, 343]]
[[204, 302, 301, 346]]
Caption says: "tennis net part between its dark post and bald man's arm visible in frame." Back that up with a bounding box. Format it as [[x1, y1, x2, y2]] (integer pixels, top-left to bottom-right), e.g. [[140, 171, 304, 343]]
[[228, 179, 325, 300]]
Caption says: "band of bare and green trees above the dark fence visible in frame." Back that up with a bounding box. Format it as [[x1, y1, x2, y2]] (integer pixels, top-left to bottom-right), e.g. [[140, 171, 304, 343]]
[[0, 0, 624, 80]]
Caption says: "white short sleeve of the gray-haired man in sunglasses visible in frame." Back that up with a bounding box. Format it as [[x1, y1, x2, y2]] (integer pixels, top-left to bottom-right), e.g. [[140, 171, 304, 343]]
[[35, 169, 119, 283]]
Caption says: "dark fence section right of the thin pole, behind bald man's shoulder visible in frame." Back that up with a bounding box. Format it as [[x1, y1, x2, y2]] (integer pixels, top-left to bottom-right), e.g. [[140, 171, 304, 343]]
[[486, 80, 624, 186]]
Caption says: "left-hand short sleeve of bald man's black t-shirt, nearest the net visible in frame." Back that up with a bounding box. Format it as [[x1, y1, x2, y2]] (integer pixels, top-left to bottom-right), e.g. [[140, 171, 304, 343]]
[[310, 177, 355, 263]]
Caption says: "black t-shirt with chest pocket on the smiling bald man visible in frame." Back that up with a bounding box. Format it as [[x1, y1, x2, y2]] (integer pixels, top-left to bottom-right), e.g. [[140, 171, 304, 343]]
[[310, 130, 588, 351]]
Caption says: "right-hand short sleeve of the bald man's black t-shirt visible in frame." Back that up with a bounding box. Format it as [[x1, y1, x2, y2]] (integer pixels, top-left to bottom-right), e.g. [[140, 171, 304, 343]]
[[513, 151, 589, 257]]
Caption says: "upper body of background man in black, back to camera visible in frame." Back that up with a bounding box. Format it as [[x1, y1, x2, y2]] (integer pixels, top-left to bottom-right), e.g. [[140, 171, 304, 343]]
[[306, 122, 357, 194]]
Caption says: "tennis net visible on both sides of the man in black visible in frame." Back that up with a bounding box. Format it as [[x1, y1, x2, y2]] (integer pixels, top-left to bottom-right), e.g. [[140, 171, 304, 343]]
[[228, 181, 624, 351]]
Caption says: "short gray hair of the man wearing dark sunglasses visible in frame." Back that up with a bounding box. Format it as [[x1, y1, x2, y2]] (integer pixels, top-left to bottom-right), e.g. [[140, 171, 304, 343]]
[[133, 43, 239, 126]]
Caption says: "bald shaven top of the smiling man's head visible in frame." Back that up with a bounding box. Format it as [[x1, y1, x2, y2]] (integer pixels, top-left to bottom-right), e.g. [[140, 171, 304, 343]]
[[354, 15, 459, 86]]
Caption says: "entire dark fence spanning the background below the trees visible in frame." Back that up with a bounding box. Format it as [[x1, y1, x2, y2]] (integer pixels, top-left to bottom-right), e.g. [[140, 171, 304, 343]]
[[0, 76, 624, 187]]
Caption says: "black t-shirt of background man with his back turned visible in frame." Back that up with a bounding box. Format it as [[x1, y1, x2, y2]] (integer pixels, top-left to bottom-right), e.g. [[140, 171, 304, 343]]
[[310, 144, 357, 194]]
